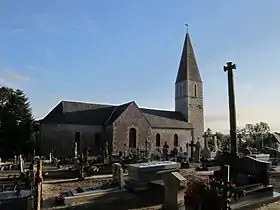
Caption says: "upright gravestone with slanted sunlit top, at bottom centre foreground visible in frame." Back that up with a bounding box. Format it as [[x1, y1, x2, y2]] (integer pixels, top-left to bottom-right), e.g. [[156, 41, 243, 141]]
[[163, 172, 186, 210]]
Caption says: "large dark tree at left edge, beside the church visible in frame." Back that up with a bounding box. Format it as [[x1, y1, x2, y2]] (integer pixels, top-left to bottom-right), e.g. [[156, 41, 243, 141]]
[[0, 87, 34, 157]]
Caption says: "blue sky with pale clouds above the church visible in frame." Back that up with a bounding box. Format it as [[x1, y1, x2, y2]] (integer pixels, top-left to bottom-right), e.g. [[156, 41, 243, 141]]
[[0, 0, 280, 131]]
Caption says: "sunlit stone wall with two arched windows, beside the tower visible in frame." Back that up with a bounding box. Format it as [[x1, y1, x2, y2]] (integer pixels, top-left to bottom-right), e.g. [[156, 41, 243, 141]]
[[149, 128, 191, 153]]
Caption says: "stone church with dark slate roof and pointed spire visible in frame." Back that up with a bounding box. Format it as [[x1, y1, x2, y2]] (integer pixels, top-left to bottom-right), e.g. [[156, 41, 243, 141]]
[[40, 33, 204, 157]]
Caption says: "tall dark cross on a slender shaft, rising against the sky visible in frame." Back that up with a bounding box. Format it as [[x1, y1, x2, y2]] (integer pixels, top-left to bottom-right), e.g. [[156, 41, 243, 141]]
[[224, 62, 238, 155]]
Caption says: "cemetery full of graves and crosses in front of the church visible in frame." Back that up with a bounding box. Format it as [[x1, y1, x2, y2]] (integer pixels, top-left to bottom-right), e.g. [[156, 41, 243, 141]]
[[0, 62, 280, 210]]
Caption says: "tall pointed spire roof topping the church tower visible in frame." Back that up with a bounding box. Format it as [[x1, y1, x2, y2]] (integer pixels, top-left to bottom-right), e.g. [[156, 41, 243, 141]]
[[176, 33, 202, 83]]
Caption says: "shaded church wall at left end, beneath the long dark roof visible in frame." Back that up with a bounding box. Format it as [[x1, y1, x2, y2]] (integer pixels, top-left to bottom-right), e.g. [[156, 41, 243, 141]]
[[40, 124, 103, 157]]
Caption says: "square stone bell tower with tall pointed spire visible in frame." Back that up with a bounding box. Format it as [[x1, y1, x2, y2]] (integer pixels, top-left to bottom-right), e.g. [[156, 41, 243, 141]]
[[175, 33, 204, 146]]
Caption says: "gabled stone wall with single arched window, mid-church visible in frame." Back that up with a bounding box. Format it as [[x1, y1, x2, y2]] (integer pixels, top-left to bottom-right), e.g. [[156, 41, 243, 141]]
[[112, 103, 151, 155]]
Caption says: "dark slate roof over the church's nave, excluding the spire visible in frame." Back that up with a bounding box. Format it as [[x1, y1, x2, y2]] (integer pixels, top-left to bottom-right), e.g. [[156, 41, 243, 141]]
[[41, 101, 193, 129]]
